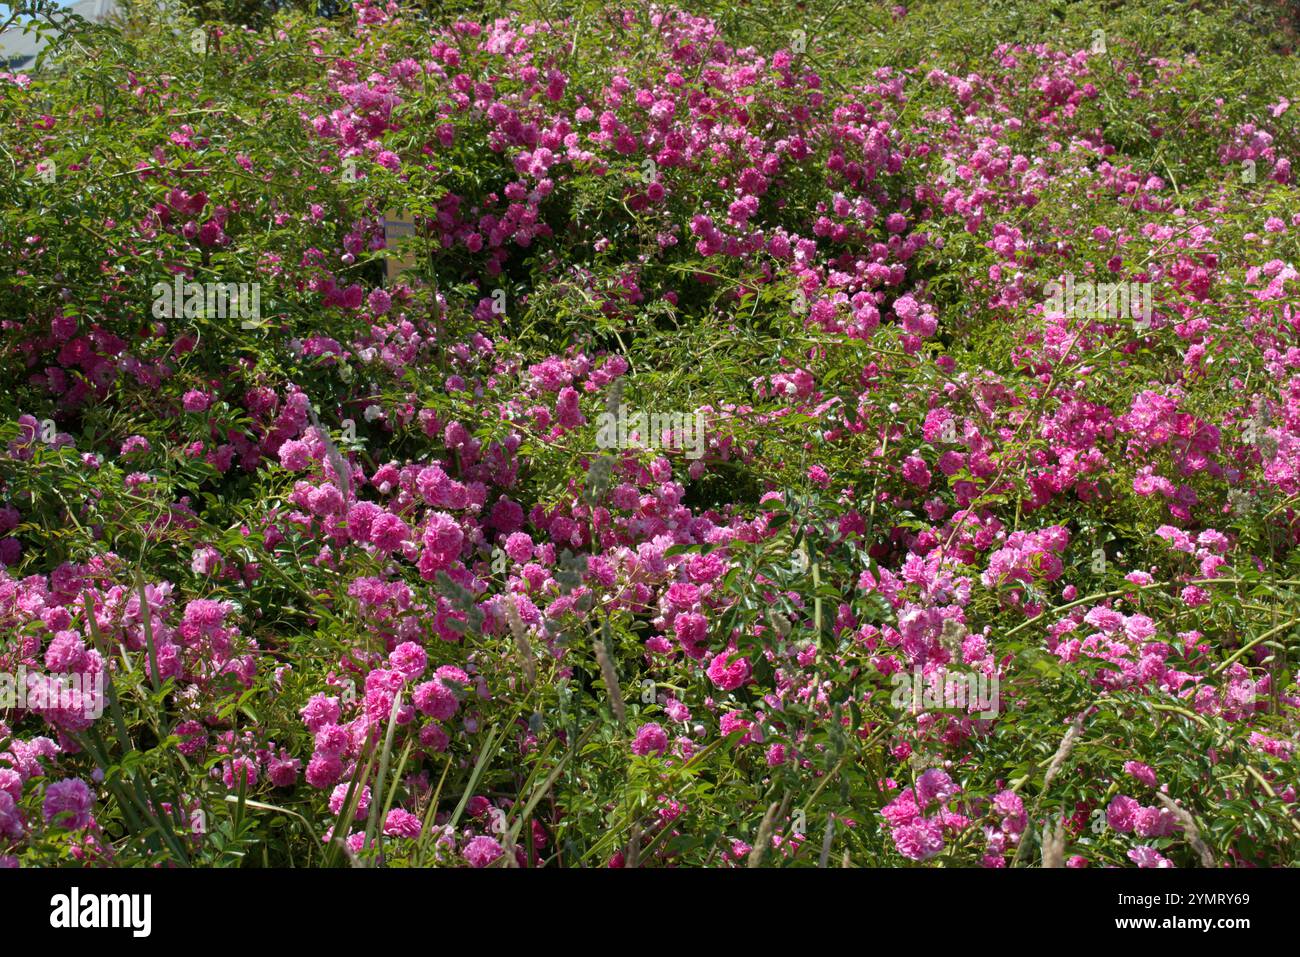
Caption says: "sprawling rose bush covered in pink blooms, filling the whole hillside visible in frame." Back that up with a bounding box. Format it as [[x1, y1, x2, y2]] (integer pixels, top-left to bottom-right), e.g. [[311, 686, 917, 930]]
[[0, 1, 1300, 867]]
